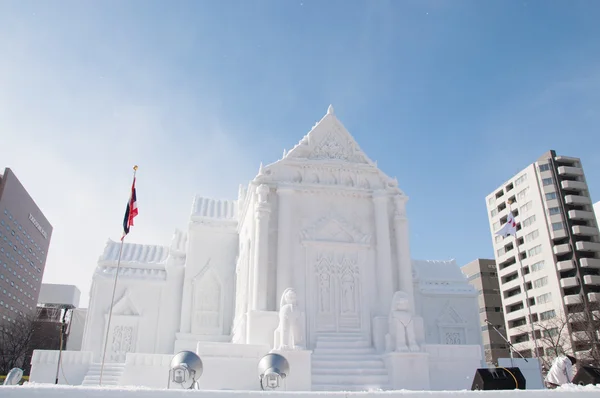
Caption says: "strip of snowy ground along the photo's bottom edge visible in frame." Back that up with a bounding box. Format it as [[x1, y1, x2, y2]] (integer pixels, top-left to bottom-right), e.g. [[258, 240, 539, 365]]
[[0, 384, 600, 398]]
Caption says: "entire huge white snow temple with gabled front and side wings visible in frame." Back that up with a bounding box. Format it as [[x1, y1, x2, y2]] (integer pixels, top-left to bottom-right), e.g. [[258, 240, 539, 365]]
[[32, 107, 482, 391]]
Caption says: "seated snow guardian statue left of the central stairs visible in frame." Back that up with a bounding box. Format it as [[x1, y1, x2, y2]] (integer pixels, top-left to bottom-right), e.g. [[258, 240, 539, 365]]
[[273, 288, 304, 350]]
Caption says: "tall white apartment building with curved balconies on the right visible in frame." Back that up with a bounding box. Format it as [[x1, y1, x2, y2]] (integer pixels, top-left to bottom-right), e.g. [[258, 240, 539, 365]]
[[486, 151, 600, 357]]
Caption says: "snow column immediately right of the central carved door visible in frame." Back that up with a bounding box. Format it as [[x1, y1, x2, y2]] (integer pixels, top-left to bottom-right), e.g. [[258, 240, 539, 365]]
[[373, 191, 394, 314]]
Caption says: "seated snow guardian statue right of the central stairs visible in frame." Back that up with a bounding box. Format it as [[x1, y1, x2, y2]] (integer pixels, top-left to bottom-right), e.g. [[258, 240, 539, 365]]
[[385, 292, 420, 352]]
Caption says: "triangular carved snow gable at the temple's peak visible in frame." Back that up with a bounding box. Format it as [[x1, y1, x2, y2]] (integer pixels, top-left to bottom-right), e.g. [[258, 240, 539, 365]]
[[283, 105, 377, 167]]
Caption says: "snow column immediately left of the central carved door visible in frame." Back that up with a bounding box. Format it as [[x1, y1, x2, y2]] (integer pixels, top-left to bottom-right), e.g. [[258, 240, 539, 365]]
[[275, 187, 294, 305]]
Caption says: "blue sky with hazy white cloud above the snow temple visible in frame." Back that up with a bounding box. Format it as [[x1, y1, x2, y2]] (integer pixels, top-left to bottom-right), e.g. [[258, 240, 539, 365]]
[[0, 0, 600, 301]]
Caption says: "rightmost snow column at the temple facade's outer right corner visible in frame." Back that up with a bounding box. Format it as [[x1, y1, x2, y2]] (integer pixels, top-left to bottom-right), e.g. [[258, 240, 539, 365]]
[[394, 195, 415, 311]]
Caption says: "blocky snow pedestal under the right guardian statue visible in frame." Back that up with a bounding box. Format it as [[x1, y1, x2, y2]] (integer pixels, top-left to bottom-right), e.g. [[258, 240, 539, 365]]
[[382, 352, 430, 390]]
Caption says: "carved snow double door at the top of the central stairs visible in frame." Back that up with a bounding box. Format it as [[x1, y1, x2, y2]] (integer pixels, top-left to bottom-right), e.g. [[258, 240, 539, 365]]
[[311, 253, 362, 333]]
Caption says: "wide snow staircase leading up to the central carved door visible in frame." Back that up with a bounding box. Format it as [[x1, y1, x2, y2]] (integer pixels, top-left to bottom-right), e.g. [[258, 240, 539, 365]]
[[312, 334, 389, 391]]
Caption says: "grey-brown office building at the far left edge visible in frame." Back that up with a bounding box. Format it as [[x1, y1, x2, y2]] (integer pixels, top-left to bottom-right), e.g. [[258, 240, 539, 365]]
[[0, 168, 52, 325]]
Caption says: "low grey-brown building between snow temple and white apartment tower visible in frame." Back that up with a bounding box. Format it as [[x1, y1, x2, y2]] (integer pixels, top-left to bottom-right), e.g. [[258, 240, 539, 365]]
[[461, 259, 510, 364]]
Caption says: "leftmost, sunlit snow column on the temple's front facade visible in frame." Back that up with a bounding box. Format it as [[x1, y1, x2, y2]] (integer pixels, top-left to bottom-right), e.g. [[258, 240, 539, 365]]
[[252, 184, 271, 311]]
